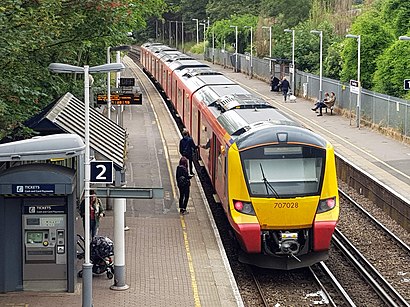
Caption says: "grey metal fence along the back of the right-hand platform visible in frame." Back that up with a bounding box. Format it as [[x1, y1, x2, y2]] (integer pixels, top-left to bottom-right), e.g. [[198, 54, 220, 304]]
[[202, 48, 410, 137]]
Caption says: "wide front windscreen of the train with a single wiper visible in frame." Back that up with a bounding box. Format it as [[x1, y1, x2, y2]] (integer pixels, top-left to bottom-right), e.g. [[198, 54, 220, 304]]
[[241, 146, 326, 198]]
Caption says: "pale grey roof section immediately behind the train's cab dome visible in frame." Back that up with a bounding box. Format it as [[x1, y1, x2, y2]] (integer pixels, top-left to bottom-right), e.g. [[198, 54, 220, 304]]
[[217, 107, 300, 136]]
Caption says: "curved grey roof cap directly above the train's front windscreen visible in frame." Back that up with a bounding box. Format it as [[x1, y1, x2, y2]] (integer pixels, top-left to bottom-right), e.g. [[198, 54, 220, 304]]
[[235, 122, 327, 150]]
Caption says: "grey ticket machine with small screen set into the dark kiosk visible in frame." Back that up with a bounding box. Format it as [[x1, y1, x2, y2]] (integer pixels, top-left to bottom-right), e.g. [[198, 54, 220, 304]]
[[22, 204, 67, 290]]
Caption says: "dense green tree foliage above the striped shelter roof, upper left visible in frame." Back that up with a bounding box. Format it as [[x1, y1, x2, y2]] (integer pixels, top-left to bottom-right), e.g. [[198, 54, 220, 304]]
[[0, 0, 164, 135]]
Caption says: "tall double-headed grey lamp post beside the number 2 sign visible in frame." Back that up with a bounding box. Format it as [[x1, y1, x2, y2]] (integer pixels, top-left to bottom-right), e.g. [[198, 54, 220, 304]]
[[48, 63, 125, 307]]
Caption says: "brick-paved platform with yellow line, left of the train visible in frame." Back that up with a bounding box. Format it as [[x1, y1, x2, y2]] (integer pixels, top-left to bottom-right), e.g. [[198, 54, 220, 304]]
[[0, 57, 243, 307]]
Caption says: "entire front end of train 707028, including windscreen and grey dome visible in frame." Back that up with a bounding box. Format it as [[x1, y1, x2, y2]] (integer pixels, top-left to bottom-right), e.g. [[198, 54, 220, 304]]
[[225, 122, 339, 270]]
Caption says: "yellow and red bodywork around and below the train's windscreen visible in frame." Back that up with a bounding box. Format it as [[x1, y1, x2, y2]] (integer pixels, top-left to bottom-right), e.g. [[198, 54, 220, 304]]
[[227, 144, 339, 270]]
